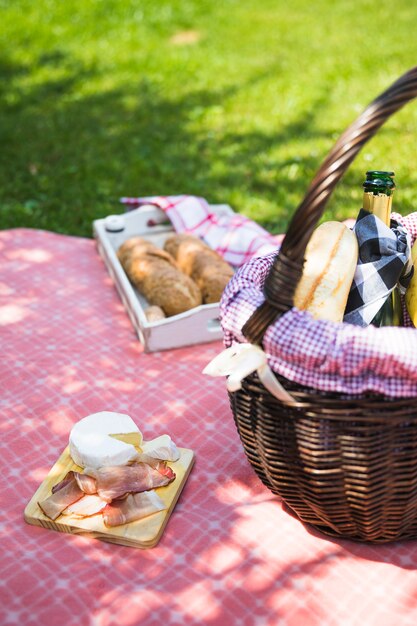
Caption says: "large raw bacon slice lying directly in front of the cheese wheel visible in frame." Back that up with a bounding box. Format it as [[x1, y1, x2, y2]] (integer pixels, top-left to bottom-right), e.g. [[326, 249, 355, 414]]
[[85, 463, 175, 502]]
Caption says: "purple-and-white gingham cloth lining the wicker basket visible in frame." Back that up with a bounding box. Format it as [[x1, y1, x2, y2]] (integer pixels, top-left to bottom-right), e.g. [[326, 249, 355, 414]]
[[220, 213, 417, 397]]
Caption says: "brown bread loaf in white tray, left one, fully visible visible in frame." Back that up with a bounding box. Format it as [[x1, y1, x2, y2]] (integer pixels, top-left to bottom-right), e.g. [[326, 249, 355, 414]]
[[117, 237, 202, 316]]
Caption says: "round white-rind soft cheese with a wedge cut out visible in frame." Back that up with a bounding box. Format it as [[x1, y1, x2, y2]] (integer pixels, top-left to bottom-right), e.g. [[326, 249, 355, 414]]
[[69, 411, 143, 469]]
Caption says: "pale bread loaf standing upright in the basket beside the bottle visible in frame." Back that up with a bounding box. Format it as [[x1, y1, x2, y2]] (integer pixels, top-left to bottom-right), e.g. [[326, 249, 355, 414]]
[[294, 222, 358, 322]]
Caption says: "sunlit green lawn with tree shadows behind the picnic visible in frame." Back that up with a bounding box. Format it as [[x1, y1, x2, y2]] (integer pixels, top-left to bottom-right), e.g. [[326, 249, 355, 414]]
[[0, 0, 417, 237]]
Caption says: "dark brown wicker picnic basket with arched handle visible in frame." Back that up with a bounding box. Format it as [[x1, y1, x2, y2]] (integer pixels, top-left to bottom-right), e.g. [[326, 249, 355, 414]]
[[229, 67, 417, 543]]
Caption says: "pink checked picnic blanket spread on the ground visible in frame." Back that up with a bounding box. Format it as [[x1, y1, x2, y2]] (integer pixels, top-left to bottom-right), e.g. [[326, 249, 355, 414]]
[[0, 229, 417, 626]]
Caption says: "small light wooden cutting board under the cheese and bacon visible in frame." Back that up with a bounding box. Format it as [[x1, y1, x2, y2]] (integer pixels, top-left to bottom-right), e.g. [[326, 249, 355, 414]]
[[24, 447, 194, 549]]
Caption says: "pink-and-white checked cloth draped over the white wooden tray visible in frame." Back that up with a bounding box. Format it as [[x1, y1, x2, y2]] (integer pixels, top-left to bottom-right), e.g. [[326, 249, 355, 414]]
[[121, 196, 281, 267]]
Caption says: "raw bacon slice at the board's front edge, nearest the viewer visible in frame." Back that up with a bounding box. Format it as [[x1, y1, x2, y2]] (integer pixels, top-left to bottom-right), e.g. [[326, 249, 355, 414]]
[[103, 491, 166, 526]]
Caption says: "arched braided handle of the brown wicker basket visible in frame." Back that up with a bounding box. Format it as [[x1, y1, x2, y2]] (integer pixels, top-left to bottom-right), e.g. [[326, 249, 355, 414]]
[[242, 66, 417, 344]]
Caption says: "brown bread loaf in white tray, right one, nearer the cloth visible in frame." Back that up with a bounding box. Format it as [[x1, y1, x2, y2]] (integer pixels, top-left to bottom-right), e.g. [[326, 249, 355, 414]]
[[164, 234, 233, 304]]
